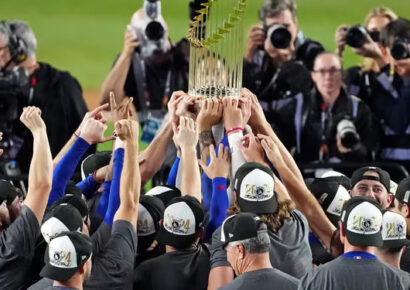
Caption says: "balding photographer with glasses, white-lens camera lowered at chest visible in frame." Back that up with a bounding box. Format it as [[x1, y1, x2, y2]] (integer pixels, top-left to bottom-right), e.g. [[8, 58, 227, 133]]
[[278, 52, 378, 162]]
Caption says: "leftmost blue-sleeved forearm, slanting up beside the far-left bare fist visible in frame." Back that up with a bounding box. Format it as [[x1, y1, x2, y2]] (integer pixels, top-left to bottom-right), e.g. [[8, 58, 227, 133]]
[[47, 137, 90, 206]]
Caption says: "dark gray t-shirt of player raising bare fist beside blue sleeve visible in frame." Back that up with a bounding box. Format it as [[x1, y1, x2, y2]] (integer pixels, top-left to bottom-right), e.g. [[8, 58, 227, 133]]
[[84, 220, 137, 290]]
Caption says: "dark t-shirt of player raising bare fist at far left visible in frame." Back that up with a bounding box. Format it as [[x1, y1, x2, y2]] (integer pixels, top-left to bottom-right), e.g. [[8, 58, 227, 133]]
[[0, 206, 40, 289]]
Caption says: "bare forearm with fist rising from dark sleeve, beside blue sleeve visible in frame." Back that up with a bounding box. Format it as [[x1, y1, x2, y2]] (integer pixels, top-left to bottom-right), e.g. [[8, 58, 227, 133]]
[[114, 120, 141, 230]]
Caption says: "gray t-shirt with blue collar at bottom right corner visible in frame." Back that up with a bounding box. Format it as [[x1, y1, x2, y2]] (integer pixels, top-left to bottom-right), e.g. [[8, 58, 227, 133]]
[[298, 256, 406, 290]]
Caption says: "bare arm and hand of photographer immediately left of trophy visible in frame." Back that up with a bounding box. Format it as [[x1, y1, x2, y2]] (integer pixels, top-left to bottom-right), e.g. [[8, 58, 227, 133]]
[[100, 29, 139, 104]]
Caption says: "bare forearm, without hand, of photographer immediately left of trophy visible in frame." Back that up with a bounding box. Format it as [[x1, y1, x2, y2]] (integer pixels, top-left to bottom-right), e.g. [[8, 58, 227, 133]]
[[100, 54, 132, 104]]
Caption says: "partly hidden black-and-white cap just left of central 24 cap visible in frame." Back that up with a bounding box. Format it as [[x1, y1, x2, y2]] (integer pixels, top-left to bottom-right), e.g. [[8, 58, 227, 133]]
[[137, 195, 165, 252]]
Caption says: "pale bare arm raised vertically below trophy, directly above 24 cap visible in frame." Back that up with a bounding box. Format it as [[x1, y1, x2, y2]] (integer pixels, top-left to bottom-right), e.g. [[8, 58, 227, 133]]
[[173, 117, 202, 201]]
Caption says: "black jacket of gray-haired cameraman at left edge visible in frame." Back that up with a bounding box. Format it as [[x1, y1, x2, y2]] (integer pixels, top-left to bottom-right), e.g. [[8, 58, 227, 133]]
[[16, 63, 89, 172]]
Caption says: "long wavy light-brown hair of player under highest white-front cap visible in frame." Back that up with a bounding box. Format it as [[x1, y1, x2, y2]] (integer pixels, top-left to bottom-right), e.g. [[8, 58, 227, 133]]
[[228, 199, 296, 232]]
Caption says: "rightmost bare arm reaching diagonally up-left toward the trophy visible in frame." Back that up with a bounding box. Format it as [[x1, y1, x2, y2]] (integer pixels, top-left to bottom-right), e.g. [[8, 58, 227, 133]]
[[261, 135, 336, 250]]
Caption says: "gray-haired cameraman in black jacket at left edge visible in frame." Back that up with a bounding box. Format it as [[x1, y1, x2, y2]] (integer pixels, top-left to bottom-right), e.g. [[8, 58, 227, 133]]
[[0, 20, 87, 174]]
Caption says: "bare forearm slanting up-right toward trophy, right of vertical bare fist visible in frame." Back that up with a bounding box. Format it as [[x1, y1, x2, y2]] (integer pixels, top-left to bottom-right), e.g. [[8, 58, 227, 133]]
[[140, 121, 173, 185]]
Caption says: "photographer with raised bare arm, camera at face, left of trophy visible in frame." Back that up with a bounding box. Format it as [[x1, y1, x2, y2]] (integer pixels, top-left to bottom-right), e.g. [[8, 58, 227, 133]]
[[100, 0, 189, 124]]
